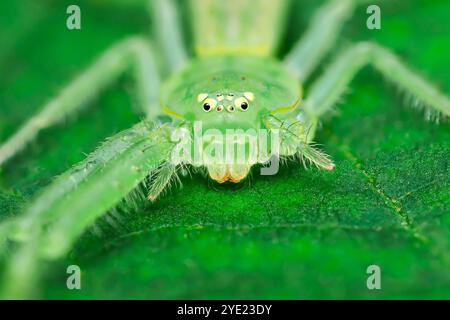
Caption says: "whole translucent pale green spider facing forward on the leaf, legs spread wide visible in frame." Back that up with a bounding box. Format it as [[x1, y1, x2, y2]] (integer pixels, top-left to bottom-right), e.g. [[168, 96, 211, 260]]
[[0, 0, 450, 296]]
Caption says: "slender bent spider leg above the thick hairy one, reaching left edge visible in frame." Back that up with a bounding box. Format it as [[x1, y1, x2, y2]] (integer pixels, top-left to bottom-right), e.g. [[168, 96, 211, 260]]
[[0, 37, 159, 166]]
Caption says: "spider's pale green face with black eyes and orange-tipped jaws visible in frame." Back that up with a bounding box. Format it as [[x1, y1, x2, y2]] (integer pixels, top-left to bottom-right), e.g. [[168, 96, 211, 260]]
[[195, 89, 260, 183]]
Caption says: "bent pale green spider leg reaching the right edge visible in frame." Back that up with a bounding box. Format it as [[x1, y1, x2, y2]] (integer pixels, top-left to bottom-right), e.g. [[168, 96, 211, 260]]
[[303, 42, 450, 118]]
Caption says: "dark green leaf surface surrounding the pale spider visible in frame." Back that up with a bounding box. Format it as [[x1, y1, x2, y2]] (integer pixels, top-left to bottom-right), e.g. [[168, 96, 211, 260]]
[[0, 0, 450, 299]]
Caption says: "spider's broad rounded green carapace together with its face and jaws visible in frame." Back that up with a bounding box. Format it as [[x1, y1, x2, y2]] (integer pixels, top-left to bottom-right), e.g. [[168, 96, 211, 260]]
[[162, 56, 301, 183]]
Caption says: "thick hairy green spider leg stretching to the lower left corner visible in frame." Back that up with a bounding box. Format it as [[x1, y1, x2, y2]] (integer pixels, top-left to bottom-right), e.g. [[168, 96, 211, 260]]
[[0, 121, 177, 298]]
